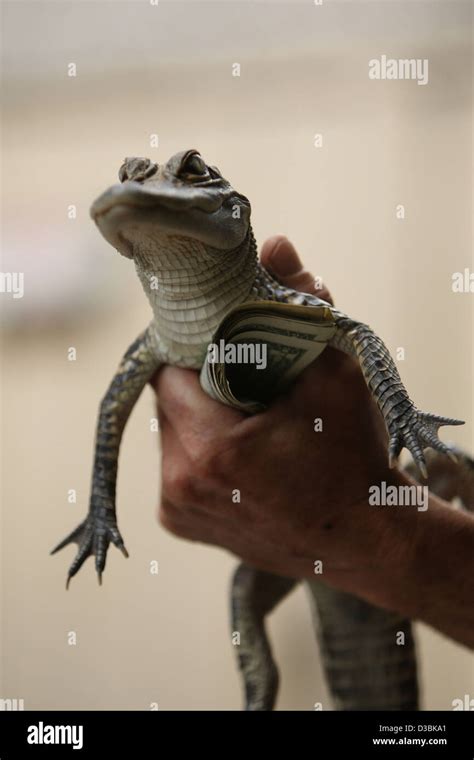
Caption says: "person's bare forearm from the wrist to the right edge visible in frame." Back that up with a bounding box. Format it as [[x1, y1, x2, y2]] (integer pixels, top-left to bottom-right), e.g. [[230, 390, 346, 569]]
[[330, 473, 474, 647]]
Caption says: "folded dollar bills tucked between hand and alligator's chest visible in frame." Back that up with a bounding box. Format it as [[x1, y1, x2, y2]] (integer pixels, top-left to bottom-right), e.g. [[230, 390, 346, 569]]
[[201, 301, 336, 413]]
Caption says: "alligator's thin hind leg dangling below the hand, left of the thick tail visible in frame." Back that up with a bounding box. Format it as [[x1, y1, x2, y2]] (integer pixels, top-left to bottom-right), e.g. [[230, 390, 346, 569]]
[[231, 564, 298, 710]]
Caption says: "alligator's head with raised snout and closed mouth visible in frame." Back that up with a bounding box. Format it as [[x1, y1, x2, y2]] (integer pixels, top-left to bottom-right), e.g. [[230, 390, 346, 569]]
[[91, 150, 250, 258]]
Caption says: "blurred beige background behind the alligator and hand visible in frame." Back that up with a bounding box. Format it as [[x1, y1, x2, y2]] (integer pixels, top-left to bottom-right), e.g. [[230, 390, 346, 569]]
[[0, 0, 474, 710]]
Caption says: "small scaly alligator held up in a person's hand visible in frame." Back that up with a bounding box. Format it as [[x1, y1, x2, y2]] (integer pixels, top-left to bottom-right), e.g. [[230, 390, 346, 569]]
[[53, 150, 472, 710]]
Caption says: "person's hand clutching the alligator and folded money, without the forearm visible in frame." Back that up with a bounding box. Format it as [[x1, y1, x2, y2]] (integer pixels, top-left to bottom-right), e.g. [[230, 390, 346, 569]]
[[155, 236, 405, 590]]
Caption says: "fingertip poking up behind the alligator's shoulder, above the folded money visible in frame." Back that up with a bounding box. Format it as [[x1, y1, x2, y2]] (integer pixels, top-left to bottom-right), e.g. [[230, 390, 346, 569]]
[[260, 235, 333, 303]]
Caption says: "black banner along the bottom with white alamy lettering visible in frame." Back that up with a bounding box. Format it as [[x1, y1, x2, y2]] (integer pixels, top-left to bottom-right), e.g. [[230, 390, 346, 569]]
[[0, 711, 474, 760]]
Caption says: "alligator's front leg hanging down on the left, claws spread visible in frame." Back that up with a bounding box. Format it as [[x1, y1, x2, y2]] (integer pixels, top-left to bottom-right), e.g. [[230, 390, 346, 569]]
[[51, 328, 161, 588]]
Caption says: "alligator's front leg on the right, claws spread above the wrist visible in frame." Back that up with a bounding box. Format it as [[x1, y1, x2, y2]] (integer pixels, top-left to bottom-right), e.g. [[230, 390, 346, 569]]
[[330, 309, 464, 478]]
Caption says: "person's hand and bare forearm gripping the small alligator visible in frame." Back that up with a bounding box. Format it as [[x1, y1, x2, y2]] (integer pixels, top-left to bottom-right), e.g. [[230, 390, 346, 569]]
[[155, 238, 474, 646]]
